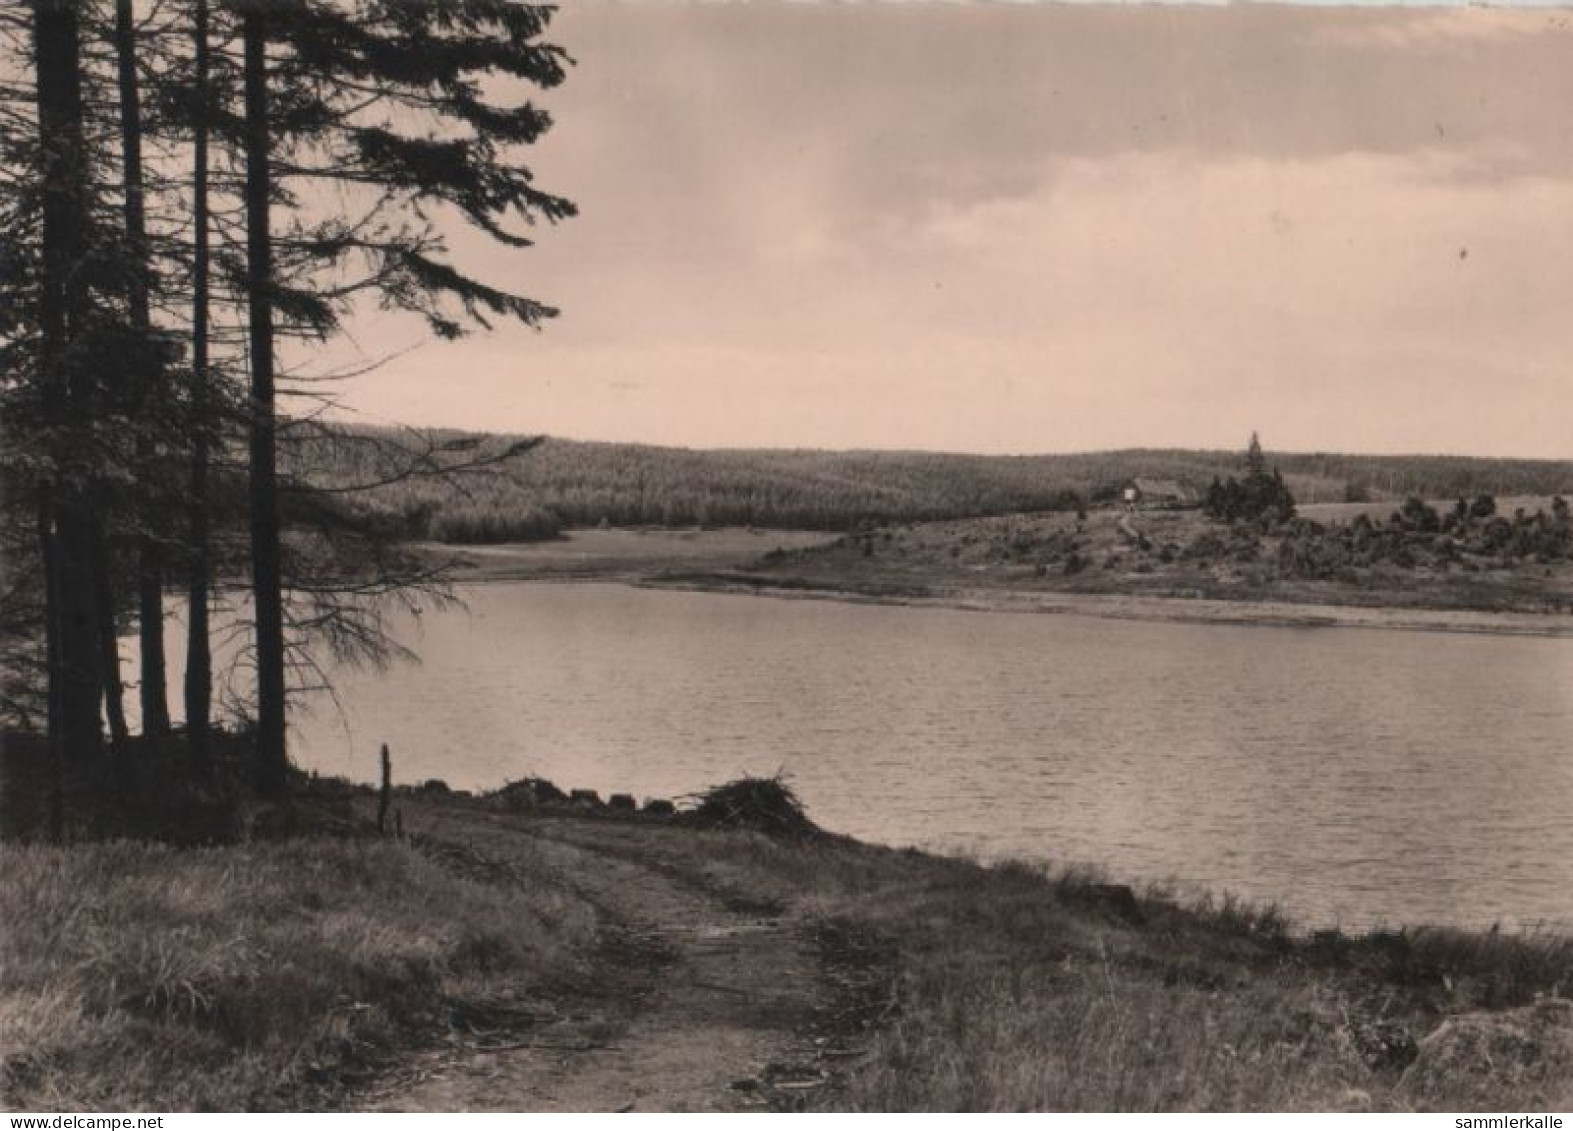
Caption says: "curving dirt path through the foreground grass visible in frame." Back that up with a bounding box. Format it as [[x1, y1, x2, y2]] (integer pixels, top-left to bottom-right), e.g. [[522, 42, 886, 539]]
[[352, 807, 826, 1111]]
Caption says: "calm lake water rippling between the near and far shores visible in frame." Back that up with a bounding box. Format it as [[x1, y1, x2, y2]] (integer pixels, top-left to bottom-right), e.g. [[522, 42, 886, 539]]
[[293, 584, 1573, 925]]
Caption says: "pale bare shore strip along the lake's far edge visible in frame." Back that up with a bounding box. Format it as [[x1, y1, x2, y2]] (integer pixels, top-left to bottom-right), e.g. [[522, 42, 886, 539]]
[[420, 527, 1573, 639]]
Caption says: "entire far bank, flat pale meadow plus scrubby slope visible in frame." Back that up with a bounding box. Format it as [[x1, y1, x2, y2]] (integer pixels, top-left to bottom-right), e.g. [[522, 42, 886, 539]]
[[422, 497, 1573, 635]]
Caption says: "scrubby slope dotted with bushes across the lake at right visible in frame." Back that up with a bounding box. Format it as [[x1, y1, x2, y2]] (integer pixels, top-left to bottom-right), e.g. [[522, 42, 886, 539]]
[[736, 510, 1573, 623]]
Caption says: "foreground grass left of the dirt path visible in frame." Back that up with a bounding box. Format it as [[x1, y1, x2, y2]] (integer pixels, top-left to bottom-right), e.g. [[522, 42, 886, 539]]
[[0, 840, 593, 1111]]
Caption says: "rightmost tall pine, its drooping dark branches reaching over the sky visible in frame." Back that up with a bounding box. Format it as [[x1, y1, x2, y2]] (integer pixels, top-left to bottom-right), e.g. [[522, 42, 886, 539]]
[[234, 0, 574, 794]]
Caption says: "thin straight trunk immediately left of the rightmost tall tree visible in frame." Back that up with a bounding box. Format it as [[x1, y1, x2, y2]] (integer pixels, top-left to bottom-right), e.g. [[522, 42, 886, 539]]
[[186, 0, 212, 780]]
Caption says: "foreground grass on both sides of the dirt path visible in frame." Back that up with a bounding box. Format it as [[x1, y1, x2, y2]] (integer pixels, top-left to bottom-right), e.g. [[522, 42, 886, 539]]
[[0, 783, 1573, 1111]]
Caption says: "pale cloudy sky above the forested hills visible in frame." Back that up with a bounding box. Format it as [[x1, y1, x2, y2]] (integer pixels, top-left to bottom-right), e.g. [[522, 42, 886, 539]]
[[322, 3, 1573, 458]]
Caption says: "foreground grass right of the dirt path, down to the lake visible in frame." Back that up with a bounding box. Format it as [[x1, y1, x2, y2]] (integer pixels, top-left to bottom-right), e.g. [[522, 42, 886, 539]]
[[522, 826, 1573, 1111]]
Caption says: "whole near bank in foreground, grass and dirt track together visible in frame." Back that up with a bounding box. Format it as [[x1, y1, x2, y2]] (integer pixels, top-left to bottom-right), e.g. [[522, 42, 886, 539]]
[[12, 783, 1573, 1112]]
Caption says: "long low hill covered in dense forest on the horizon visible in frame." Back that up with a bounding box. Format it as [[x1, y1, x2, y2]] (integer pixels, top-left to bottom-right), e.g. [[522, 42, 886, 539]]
[[295, 429, 1573, 541]]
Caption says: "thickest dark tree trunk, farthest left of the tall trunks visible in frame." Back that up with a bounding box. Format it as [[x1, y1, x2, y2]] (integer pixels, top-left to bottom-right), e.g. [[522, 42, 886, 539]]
[[33, 0, 104, 770]]
